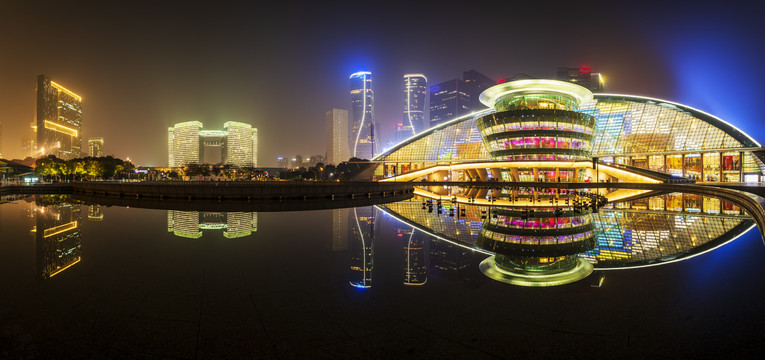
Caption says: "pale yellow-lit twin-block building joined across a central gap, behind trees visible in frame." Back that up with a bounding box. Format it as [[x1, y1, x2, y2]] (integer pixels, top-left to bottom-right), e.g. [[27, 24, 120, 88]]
[[167, 121, 258, 167]]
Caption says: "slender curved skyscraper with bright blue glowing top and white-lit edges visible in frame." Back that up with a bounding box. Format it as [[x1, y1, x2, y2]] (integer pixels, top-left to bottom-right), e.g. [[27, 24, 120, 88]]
[[348, 71, 378, 159]]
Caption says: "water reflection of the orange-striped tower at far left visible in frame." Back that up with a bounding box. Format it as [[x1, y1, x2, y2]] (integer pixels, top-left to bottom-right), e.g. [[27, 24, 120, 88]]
[[35, 204, 82, 280]]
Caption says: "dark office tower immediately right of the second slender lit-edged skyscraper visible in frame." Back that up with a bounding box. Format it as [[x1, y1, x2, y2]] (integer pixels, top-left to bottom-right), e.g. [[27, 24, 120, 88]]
[[430, 79, 470, 127]]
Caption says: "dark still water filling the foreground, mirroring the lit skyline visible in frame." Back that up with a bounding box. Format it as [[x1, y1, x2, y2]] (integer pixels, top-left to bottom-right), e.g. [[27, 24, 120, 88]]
[[0, 198, 765, 359]]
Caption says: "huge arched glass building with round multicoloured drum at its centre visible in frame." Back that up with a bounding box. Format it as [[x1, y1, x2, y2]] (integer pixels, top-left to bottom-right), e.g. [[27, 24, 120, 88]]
[[373, 79, 765, 186]]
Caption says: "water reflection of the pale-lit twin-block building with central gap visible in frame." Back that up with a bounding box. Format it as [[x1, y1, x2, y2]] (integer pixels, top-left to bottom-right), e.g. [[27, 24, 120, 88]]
[[167, 210, 258, 239]]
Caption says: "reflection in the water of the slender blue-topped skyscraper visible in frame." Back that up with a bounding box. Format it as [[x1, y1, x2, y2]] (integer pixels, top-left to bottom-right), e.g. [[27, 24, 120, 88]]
[[350, 206, 377, 288]]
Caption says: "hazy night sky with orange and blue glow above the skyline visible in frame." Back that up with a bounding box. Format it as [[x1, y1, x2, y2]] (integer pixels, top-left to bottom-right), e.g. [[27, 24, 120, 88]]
[[0, 0, 765, 166]]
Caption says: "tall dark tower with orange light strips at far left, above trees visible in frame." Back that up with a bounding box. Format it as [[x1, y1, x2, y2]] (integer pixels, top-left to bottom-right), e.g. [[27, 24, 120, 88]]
[[36, 75, 82, 160]]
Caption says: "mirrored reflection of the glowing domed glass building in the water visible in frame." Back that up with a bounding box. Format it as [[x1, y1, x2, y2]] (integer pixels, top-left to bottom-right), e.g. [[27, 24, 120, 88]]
[[379, 193, 755, 287]]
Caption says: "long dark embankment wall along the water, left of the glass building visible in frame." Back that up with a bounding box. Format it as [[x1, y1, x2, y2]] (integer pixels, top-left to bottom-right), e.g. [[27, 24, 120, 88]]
[[72, 181, 414, 200]]
